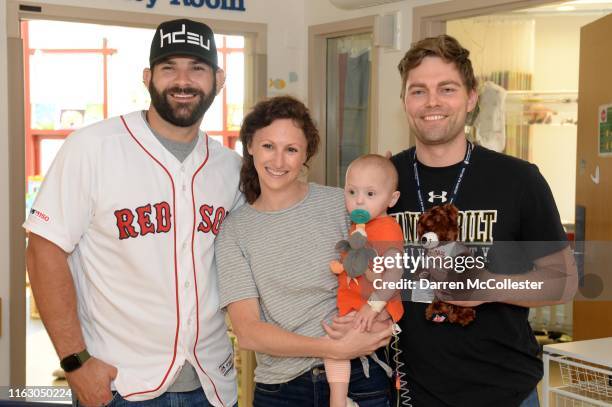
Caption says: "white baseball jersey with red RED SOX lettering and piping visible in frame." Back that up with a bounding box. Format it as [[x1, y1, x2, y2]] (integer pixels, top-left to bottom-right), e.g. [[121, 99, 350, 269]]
[[24, 112, 243, 407]]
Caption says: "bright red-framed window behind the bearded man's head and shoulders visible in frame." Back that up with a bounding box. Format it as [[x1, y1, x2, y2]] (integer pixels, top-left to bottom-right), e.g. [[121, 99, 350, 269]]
[[21, 20, 245, 183]]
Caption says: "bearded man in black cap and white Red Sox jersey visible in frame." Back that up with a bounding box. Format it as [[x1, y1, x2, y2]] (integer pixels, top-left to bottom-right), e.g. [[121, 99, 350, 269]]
[[24, 19, 243, 407]]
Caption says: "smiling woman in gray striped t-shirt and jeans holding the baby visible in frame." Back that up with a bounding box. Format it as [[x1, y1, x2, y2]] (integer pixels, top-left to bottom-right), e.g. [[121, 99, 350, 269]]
[[215, 97, 391, 407]]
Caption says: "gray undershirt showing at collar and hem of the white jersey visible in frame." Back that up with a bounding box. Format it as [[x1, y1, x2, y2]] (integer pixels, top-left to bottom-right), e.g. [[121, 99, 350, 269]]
[[142, 110, 202, 393]]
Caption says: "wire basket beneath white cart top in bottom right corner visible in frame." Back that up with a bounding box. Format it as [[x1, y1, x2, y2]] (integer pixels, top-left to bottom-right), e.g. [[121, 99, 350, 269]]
[[557, 357, 612, 406]]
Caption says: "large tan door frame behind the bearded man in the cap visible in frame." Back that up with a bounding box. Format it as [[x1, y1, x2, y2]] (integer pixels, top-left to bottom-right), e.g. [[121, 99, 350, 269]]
[[5, 0, 268, 387]]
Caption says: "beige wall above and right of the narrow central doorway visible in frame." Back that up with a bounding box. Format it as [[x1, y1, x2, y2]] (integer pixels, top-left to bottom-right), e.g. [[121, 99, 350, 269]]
[[303, 0, 440, 153]]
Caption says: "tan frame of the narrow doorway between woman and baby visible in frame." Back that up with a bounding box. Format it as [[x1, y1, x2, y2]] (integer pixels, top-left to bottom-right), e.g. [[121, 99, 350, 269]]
[[308, 16, 378, 185]]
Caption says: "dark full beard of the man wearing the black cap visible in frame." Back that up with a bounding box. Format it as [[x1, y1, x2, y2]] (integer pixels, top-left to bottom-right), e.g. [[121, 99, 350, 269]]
[[149, 81, 217, 127]]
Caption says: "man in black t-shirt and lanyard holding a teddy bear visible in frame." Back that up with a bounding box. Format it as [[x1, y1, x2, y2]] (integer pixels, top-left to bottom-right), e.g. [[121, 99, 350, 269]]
[[389, 35, 577, 407]]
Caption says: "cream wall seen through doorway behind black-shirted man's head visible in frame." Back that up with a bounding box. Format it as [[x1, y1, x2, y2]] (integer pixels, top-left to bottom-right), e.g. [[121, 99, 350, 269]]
[[447, 14, 600, 91]]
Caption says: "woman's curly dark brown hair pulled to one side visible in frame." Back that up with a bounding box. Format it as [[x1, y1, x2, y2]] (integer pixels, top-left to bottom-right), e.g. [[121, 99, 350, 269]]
[[240, 96, 319, 204]]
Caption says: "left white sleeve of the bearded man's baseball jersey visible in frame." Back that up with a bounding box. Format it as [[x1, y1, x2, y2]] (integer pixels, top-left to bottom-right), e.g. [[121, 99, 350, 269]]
[[23, 133, 97, 253]]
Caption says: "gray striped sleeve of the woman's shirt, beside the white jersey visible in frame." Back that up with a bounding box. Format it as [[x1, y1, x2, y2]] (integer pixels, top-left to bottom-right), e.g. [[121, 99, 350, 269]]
[[215, 220, 259, 308]]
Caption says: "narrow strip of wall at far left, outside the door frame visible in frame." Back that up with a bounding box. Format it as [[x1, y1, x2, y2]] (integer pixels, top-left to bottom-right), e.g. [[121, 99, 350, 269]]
[[0, 0, 9, 386]]
